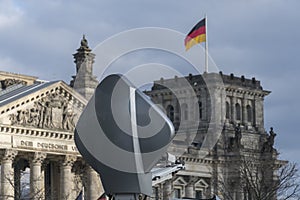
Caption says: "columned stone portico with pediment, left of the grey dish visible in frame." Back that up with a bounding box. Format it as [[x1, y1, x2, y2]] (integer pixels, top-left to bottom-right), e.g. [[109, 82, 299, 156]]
[[0, 75, 103, 200]]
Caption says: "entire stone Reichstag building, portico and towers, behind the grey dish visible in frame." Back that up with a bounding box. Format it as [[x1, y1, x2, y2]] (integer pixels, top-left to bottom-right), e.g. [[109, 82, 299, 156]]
[[0, 38, 281, 200]]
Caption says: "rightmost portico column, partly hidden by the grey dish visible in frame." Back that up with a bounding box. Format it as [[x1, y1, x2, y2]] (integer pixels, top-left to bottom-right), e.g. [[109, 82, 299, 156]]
[[85, 166, 104, 199]]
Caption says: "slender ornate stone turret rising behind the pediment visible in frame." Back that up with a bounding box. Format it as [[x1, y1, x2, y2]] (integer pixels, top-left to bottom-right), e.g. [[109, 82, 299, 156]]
[[70, 35, 98, 100]]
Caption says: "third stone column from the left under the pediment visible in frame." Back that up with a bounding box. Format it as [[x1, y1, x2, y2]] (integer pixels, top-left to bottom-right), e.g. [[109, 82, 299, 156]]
[[59, 155, 76, 200]]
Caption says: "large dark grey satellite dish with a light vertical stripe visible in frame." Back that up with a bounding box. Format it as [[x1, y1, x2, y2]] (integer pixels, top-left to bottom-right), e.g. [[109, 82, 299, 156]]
[[75, 74, 175, 196]]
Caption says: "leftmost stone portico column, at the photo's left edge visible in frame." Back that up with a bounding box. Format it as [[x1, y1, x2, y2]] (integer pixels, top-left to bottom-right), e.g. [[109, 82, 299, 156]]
[[0, 149, 18, 200]]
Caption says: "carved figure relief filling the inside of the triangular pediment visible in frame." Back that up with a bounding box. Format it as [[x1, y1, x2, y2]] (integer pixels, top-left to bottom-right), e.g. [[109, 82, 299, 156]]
[[9, 91, 77, 131]]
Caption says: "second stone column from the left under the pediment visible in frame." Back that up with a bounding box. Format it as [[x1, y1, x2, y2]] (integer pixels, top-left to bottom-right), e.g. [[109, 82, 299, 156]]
[[30, 152, 47, 200]]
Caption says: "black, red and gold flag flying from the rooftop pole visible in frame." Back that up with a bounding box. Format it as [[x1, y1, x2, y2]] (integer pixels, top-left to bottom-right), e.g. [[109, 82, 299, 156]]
[[184, 18, 206, 51]]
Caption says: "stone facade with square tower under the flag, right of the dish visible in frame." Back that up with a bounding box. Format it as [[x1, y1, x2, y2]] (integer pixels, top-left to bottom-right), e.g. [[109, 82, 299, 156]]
[[146, 72, 280, 200]]
